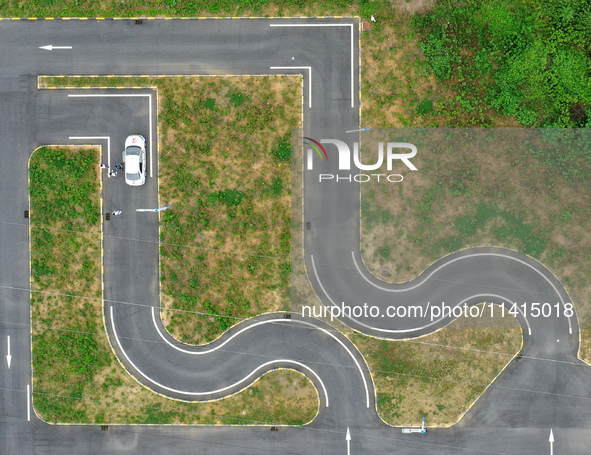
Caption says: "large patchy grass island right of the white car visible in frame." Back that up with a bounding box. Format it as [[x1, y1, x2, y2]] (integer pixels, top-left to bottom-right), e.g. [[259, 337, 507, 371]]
[[42, 76, 301, 343]]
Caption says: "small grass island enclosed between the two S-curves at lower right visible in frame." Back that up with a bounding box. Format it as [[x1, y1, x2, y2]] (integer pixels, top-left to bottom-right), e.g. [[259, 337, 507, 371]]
[[349, 306, 521, 426]]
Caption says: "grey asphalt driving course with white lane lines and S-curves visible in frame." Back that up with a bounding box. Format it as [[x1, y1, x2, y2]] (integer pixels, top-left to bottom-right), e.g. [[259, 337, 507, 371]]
[[0, 19, 591, 454]]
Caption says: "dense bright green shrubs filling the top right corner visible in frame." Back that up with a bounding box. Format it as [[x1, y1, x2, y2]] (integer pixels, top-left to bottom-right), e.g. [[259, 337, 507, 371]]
[[412, 0, 591, 127]]
